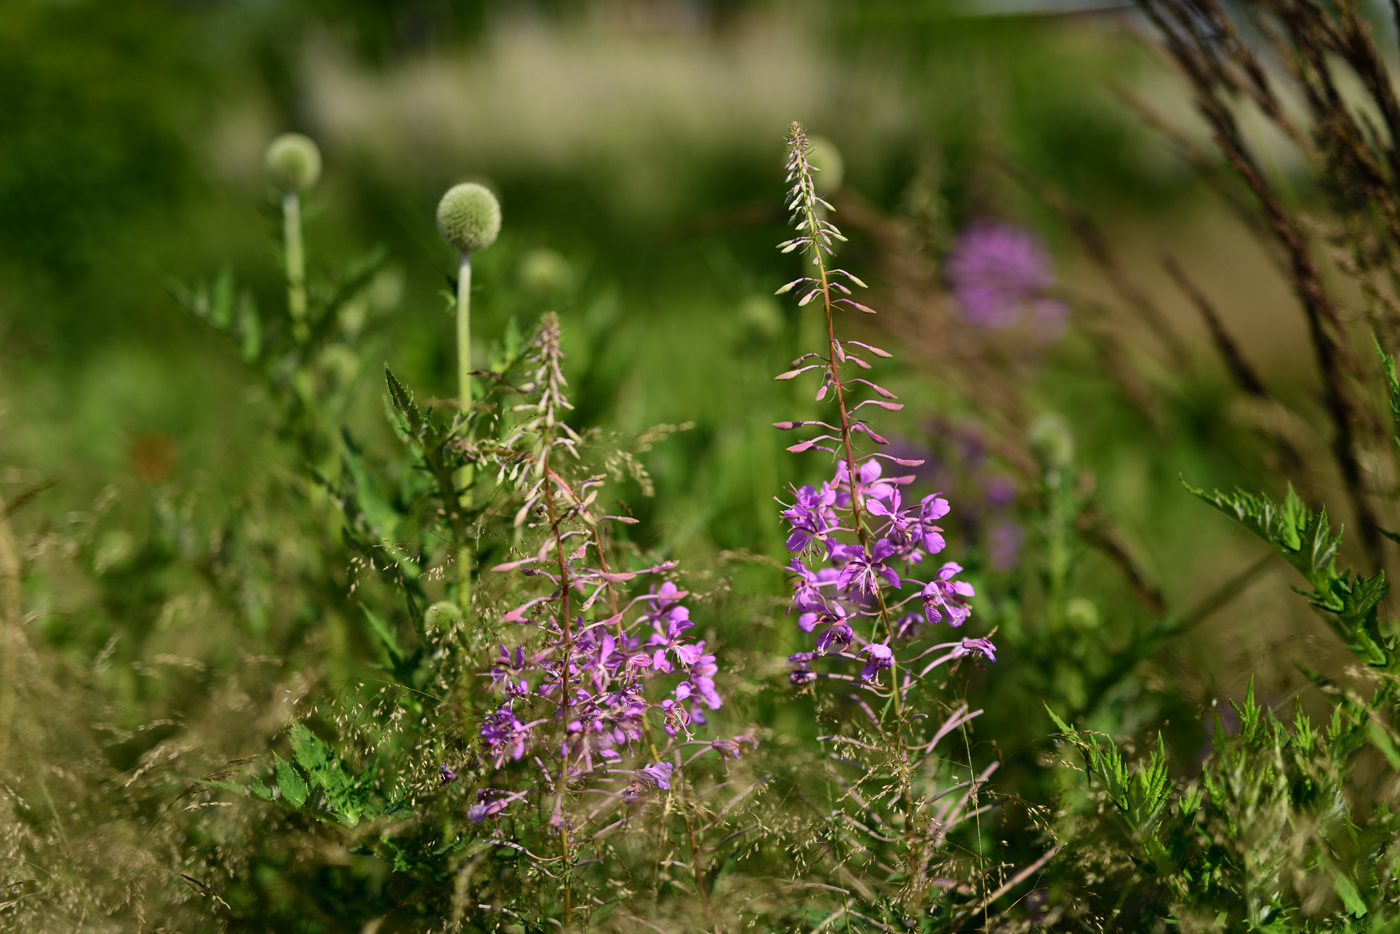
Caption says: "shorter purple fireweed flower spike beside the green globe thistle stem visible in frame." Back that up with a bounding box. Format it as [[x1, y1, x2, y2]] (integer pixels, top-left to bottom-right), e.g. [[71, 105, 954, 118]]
[[470, 315, 746, 829]]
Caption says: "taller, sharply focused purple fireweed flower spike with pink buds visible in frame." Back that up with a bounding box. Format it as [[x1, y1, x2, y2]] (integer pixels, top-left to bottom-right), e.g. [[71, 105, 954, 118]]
[[776, 125, 995, 693]]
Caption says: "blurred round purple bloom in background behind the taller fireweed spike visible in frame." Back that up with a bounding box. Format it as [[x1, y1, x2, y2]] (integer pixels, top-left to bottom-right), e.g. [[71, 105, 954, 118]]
[[945, 220, 1067, 336]]
